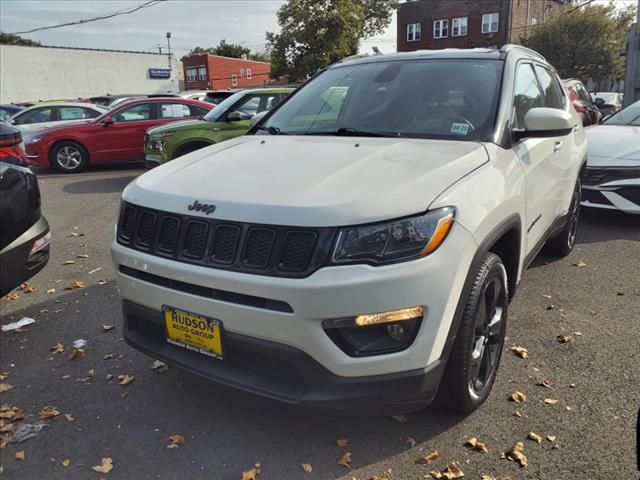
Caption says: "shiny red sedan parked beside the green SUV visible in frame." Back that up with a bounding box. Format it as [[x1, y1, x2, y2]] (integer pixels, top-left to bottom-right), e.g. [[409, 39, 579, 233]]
[[26, 97, 214, 173]]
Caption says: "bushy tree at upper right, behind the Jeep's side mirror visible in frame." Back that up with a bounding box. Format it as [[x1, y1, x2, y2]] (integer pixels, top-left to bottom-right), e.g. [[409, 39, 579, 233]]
[[520, 3, 635, 82]]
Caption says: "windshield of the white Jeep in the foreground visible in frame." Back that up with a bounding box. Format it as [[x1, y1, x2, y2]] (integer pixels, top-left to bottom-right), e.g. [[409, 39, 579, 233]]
[[258, 59, 502, 140]]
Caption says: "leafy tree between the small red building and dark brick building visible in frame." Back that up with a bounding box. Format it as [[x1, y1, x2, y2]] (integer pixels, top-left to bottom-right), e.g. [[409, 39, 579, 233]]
[[267, 0, 398, 80]]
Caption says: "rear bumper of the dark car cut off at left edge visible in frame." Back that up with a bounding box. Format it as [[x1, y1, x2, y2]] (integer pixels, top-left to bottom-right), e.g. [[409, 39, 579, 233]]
[[0, 216, 50, 295]]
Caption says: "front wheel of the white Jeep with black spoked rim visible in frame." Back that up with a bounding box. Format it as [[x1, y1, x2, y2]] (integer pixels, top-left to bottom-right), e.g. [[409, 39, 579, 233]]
[[437, 253, 509, 414]]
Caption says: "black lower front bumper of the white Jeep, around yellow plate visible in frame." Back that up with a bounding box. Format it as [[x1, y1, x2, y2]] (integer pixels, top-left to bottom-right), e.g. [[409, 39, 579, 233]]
[[123, 300, 444, 414]]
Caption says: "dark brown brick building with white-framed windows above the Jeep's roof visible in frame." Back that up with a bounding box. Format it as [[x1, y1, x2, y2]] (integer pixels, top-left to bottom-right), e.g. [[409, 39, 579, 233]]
[[398, 0, 574, 52]]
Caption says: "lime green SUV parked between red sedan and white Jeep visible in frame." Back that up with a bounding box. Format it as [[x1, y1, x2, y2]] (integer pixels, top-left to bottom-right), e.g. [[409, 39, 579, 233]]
[[144, 87, 294, 168]]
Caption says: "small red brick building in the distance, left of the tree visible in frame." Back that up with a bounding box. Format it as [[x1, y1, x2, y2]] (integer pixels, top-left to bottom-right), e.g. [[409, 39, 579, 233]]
[[182, 54, 271, 90]]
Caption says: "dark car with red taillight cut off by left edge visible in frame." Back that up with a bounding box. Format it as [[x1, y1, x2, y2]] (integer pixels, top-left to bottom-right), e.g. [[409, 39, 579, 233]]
[[0, 122, 50, 296]]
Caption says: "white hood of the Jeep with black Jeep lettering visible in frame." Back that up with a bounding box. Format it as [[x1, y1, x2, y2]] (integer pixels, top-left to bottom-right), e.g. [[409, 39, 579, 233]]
[[123, 135, 488, 227]]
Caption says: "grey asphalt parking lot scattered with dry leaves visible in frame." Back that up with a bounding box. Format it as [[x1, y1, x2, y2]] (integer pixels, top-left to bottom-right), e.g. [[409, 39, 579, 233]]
[[0, 167, 640, 480]]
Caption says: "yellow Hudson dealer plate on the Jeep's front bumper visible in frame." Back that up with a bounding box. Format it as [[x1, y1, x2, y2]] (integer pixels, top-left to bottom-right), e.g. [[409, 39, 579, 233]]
[[162, 305, 224, 359]]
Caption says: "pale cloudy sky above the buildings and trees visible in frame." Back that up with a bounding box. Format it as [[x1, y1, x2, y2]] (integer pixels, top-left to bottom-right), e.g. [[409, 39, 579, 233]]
[[0, 0, 636, 58]]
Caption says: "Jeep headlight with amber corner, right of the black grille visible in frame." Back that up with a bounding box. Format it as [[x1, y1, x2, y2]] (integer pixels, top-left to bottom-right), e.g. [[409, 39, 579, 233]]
[[331, 207, 455, 264]]
